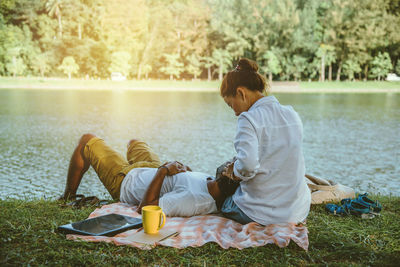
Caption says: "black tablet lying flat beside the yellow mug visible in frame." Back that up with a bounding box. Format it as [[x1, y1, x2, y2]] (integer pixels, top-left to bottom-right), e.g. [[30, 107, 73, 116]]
[[57, 213, 142, 236]]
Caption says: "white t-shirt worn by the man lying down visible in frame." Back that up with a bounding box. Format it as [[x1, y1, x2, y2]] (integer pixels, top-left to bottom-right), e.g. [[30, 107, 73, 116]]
[[120, 168, 217, 217]]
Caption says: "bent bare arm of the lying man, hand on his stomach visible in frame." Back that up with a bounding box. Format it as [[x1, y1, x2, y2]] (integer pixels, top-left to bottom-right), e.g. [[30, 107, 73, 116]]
[[138, 161, 191, 213]]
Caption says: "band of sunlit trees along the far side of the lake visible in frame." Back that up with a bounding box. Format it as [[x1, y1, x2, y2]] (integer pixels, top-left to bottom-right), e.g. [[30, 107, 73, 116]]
[[0, 0, 400, 80]]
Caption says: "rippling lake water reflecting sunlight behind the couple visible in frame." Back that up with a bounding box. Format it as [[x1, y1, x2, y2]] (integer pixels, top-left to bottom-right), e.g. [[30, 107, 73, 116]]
[[0, 90, 400, 199]]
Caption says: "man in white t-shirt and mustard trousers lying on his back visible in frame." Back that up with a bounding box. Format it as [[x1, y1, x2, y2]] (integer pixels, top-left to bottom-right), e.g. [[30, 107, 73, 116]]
[[60, 134, 239, 217]]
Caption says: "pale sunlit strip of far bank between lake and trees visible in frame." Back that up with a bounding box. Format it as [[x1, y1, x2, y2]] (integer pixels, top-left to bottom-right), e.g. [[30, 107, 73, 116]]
[[0, 77, 400, 93]]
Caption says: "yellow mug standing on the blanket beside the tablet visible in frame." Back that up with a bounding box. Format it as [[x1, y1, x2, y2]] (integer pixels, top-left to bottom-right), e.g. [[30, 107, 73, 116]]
[[142, 205, 166, 234]]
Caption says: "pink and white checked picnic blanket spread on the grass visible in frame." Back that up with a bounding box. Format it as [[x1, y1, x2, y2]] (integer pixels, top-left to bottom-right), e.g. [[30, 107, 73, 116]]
[[67, 203, 308, 250]]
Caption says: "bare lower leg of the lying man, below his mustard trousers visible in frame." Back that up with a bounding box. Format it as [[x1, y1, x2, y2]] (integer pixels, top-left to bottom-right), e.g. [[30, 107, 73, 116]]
[[60, 134, 96, 200]]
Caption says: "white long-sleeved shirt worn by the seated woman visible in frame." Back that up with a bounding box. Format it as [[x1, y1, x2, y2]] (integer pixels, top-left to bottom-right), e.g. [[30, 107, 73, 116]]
[[233, 96, 311, 225]]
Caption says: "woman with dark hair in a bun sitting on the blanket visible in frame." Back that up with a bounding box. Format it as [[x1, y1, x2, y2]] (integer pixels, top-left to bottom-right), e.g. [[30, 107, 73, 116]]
[[220, 58, 311, 225]]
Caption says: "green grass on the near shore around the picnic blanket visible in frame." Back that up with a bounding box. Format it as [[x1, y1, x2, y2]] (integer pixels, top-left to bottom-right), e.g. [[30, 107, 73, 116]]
[[0, 196, 400, 266]]
